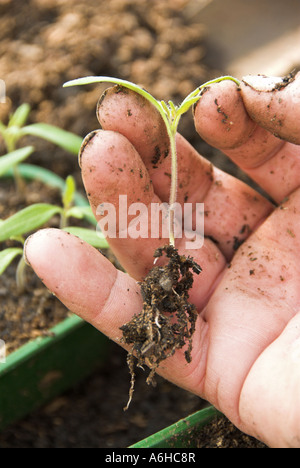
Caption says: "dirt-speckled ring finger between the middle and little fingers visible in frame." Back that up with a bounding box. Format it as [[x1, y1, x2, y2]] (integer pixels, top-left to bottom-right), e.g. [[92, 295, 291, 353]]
[[81, 130, 225, 307]]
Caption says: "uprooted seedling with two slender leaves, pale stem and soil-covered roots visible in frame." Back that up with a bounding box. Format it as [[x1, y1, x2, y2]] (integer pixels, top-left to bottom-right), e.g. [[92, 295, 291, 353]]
[[64, 76, 239, 409]]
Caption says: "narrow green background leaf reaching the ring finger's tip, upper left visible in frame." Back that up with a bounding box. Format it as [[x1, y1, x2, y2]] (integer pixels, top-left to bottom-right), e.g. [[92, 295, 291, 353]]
[[22, 123, 83, 155]]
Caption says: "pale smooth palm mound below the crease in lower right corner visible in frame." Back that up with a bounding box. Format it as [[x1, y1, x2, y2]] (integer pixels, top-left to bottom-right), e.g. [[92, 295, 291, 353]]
[[240, 312, 300, 448]]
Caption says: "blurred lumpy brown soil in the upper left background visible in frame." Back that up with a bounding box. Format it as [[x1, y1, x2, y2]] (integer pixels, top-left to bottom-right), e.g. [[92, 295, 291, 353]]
[[0, 0, 219, 179]]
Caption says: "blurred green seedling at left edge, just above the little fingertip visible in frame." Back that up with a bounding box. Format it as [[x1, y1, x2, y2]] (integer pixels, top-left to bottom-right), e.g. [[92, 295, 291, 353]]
[[0, 176, 108, 293]]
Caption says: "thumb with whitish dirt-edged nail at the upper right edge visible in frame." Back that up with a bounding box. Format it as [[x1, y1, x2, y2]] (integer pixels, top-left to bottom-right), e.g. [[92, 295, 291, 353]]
[[241, 73, 300, 145]]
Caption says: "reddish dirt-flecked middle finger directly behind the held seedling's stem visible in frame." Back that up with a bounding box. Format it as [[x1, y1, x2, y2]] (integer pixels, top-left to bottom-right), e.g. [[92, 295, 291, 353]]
[[97, 87, 272, 260]]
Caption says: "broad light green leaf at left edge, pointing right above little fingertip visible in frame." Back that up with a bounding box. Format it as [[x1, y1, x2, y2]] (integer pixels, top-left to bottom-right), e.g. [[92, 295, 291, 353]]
[[0, 203, 62, 242]]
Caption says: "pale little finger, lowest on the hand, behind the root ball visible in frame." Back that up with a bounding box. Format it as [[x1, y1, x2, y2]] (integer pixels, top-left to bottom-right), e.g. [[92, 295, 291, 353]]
[[25, 229, 207, 392]]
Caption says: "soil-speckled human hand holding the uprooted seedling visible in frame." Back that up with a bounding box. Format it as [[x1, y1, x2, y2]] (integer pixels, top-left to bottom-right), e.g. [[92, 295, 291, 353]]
[[25, 75, 300, 447]]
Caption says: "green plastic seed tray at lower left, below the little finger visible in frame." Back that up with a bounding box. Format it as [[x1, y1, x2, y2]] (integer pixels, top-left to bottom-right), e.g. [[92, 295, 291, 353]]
[[0, 315, 109, 429]]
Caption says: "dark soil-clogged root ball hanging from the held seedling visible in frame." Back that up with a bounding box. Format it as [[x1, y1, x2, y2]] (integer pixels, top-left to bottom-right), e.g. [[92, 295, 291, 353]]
[[121, 245, 201, 409]]
